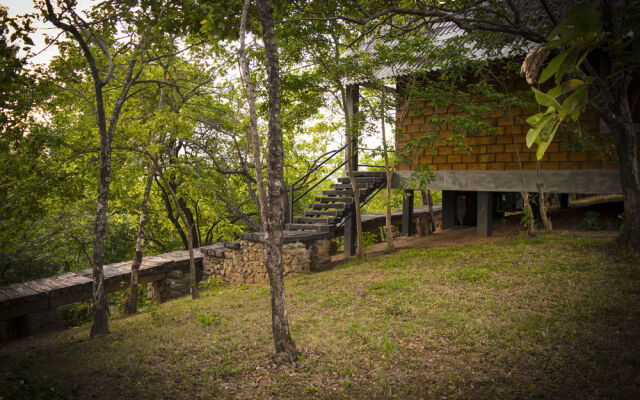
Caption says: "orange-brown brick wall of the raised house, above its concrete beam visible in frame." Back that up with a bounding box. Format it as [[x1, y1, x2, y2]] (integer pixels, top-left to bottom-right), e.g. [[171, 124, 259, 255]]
[[396, 101, 618, 171]]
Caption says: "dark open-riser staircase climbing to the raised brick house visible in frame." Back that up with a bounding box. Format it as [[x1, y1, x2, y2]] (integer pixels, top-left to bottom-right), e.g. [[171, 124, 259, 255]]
[[285, 171, 386, 237]]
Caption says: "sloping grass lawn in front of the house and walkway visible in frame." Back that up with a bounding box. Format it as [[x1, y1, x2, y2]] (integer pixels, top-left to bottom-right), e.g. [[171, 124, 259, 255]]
[[0, 235, 640, 399]]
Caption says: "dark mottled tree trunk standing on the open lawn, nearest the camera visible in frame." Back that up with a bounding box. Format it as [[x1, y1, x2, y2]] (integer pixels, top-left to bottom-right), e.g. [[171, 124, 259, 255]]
[[257, 0, 298, 363]]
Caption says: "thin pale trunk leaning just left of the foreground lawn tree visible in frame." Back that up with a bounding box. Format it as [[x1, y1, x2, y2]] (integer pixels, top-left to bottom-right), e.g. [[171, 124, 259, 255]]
[[238, 0, 267, 225]]
